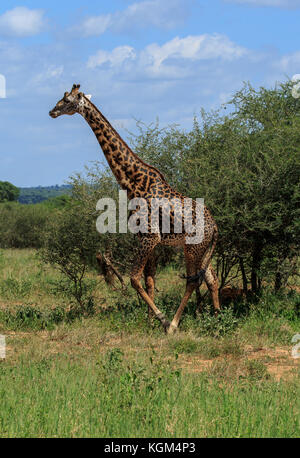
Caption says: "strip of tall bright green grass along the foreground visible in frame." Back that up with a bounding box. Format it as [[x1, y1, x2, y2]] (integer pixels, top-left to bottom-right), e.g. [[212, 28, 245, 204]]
[[0, 350, 300, 437]]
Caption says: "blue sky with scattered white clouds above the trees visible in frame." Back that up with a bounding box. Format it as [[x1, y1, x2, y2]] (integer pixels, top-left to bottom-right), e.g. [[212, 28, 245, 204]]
[[0, 0, 300, 186]]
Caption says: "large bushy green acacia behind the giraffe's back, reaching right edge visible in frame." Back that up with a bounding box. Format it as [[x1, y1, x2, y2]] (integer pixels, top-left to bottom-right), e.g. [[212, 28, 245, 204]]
[[131, 82, 300, 292]]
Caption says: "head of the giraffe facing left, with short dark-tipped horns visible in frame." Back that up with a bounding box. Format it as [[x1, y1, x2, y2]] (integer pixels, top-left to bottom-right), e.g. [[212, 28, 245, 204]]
[[49, 84, 91, 118]]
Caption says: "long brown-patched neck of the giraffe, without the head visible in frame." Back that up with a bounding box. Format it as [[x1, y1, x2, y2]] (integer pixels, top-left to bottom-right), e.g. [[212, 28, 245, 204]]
[[79, 99, 165, 198]]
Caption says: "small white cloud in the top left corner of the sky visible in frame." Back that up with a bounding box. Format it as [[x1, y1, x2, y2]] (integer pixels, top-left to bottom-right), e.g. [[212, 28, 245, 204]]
[[0, 6, 44, 37]]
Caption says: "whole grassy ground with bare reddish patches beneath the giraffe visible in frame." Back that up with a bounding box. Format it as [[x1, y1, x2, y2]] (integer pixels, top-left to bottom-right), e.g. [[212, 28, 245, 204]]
[[0, 250, 300, 438]]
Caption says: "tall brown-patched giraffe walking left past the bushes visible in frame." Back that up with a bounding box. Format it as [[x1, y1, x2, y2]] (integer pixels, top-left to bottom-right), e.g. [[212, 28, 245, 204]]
[[49, 84, 220, 334]]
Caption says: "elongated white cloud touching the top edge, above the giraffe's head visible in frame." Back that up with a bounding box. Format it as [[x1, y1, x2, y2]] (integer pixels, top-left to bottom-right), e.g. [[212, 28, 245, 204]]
[[75, 0, 189, 36]]
